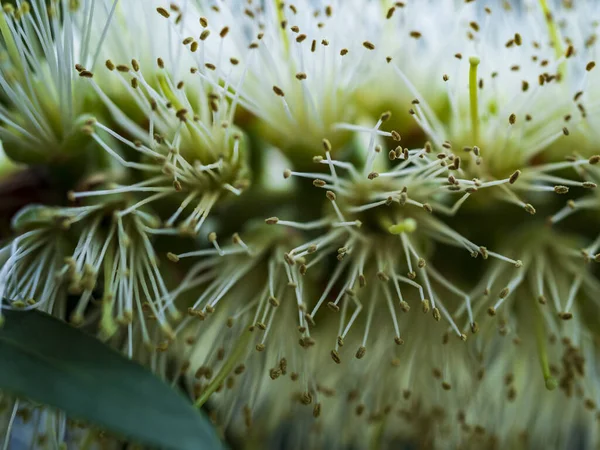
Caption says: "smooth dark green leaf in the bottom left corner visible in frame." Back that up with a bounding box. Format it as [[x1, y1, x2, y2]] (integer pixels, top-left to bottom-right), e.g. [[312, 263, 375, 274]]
[[0, 310, 222, 450]]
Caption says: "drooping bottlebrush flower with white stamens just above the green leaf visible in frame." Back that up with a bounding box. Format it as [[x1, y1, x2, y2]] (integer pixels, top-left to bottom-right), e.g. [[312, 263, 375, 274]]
[[0, 203, 179, 344]]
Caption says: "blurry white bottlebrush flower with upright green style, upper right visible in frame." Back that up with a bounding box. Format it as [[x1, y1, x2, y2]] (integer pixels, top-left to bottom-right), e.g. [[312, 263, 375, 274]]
[[382, 2, 595, 214]]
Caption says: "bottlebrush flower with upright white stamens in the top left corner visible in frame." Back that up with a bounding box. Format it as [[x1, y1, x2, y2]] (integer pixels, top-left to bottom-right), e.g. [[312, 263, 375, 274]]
[[0, 0, 118, 164]]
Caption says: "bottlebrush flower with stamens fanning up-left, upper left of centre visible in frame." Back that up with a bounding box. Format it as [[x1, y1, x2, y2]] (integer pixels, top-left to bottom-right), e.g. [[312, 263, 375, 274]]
[[69, 54, 249, 235]]
